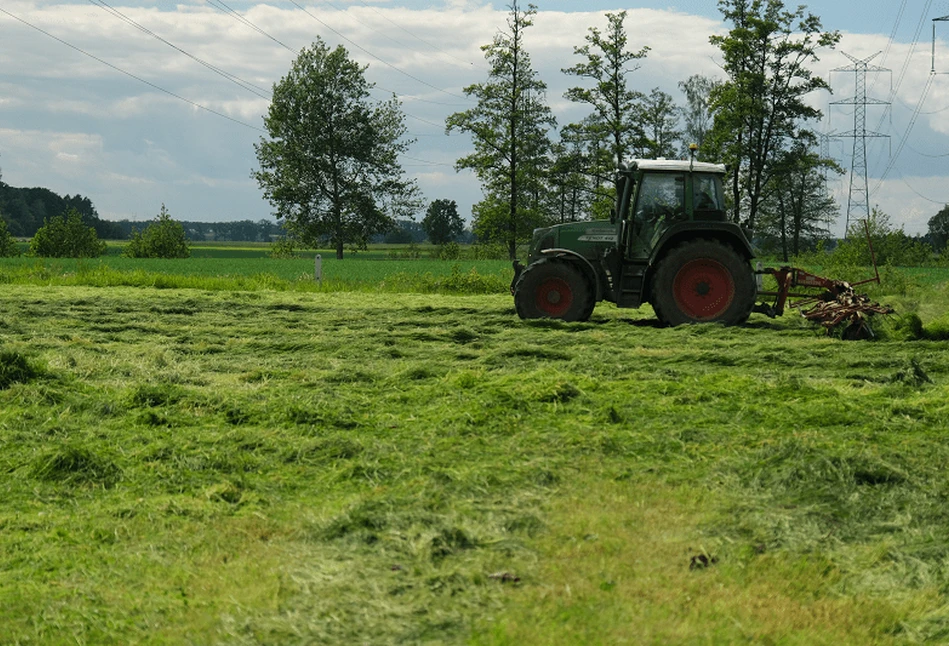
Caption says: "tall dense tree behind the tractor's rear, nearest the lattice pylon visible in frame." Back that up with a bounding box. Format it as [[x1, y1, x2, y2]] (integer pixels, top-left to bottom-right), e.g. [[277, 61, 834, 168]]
[[709, 0, 840, 229]]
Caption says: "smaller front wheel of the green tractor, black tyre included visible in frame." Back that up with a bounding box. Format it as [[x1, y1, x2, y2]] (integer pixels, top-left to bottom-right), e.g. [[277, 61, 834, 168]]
[[514, 258, 596, 321]]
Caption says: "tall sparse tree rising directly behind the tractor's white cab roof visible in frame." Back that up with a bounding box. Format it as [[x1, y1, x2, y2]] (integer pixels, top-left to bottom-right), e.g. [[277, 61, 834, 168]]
[[562, 11, 649, 176]]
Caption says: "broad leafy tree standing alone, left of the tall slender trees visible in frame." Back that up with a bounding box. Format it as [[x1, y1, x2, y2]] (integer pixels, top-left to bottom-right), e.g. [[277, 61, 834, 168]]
[[253, 39, 418, 259]]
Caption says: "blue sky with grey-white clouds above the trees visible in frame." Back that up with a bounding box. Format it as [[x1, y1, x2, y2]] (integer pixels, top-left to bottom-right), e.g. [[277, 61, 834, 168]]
[[0, 0, 949, 235]]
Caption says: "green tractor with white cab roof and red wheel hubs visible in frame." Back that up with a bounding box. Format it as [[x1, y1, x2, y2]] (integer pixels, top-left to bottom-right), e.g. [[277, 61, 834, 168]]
[[511, 160, 757, 325]]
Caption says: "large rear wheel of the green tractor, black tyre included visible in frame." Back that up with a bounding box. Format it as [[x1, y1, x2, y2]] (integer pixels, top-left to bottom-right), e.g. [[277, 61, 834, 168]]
[[650, 240, 756, 325]]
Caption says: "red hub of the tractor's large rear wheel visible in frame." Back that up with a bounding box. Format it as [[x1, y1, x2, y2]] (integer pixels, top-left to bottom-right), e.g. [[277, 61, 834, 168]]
[[672, 258, 735, 321]]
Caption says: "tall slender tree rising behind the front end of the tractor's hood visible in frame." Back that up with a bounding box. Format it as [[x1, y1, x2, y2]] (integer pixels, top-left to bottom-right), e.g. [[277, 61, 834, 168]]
[[446, 0, 556, 259]]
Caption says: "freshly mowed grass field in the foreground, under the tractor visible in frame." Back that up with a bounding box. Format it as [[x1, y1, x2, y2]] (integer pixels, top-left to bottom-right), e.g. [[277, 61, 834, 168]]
[[0, 259, 949, 644]]
